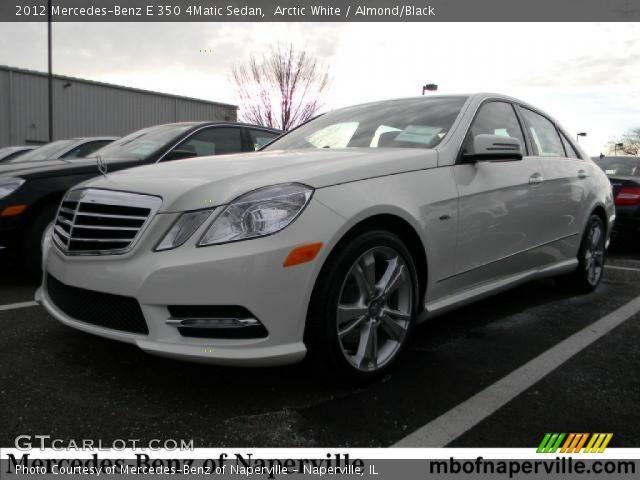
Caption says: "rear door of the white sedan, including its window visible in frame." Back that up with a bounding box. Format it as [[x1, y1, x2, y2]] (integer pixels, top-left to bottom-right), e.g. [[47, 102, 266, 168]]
[[520, 107, 590, 253]]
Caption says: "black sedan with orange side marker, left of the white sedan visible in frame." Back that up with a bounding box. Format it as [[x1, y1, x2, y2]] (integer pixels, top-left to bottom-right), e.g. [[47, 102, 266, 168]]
[[0, 122, 280, 275]]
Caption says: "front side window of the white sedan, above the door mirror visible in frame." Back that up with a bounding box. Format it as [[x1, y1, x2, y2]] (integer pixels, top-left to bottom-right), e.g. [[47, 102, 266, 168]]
[[464, 102, 527, 153]]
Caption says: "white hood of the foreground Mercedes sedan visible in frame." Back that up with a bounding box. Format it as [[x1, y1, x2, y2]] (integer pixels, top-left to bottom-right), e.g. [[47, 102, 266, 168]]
[[80, 148, 438, 212]]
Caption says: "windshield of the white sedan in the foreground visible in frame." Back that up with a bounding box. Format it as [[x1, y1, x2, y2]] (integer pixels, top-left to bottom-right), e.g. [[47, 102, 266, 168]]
[[264, 97, 466, 150]]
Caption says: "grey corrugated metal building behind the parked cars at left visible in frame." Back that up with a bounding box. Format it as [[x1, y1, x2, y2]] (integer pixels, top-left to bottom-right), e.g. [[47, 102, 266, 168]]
[[0, 65, 238, 147]]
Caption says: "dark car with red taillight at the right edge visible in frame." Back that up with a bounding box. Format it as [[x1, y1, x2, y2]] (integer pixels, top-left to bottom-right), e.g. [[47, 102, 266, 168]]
[[594, 157, 640, 236]]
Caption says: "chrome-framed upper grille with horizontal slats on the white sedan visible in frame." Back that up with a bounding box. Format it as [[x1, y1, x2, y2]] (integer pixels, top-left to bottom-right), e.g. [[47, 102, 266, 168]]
[[53, 189, 162, 255]]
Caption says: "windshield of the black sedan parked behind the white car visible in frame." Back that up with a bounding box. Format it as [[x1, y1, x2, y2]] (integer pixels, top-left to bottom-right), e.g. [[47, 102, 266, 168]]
[[92, 124, 193, 160]]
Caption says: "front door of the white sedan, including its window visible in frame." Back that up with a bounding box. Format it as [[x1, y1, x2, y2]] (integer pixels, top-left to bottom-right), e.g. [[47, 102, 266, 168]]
[[451, 101, 542, 291]]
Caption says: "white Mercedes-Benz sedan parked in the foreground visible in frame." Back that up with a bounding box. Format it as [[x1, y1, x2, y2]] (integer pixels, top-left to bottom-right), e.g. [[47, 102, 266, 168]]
[[38, 94, 614, 378]]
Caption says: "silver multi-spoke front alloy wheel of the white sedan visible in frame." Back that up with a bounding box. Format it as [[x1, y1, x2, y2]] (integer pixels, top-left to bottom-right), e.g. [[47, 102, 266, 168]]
[[336, 246, 414, 372]]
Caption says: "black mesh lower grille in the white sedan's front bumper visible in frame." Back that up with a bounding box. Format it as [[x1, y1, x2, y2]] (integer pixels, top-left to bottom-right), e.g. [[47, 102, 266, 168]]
[[47, 273, 149, 335]]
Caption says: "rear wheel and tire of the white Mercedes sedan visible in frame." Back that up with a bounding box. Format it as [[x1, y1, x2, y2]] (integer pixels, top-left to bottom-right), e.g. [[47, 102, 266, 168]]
[[560, 215, 606, 293]]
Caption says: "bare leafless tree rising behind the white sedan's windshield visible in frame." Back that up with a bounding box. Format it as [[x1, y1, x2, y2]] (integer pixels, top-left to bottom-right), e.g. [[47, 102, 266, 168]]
[[232, 45, 329, 131]]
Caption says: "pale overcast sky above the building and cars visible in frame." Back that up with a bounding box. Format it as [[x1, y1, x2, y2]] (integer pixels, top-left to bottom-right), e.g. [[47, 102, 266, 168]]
[[0, 23, 640, 155]]
